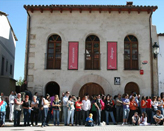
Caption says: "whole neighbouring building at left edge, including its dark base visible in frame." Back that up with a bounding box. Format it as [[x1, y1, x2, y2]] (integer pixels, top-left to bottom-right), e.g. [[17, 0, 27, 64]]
[[0, 11, 17, 95]]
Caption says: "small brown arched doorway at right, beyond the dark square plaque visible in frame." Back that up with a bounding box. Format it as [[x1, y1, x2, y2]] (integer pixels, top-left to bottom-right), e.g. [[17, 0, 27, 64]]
[[124, 82, 140, 95]]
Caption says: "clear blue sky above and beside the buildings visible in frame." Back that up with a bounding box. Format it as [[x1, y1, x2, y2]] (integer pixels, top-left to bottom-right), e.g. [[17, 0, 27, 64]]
[[0, 0, 164, 80]]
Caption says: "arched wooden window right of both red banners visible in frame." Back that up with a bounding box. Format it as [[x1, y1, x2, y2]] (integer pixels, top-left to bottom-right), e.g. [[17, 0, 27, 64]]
[[124, 35, 138, 70]]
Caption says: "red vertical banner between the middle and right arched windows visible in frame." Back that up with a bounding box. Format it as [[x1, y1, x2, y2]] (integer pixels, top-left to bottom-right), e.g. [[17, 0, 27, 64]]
[[107, 42, 117, 70]]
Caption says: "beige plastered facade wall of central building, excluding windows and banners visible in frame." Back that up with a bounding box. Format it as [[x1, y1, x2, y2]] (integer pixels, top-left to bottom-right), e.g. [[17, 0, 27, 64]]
[[28, 11, 158, 95]]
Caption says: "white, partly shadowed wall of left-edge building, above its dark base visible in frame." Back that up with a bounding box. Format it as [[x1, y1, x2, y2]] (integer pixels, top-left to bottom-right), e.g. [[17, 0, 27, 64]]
[[0, 14, 16, 78]]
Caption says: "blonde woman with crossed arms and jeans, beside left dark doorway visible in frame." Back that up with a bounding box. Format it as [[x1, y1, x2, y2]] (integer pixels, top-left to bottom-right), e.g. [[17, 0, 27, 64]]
[[52, 95, 61, 126]]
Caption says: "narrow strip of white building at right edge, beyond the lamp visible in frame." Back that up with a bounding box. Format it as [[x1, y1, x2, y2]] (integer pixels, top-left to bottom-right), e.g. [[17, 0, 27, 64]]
[[158, 33, 164, 93]]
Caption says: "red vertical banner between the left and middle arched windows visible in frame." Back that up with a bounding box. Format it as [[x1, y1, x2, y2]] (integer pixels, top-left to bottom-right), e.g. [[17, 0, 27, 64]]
[[68, 42, 78, 70]]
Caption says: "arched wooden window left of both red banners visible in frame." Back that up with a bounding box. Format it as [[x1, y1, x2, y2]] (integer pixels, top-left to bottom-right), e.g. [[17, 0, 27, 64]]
[[47, 35, 61, 69]]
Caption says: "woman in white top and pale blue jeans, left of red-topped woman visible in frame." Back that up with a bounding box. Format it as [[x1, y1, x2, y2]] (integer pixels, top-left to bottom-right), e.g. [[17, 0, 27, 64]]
[[67, 96, 75, 126]]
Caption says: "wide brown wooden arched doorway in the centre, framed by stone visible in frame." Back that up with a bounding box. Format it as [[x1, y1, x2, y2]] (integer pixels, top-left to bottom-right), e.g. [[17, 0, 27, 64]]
[[79, 83, 104, 98]]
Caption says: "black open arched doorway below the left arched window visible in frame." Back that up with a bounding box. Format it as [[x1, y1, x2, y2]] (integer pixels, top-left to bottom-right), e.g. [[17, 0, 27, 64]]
[[45, 82, 60, 96]]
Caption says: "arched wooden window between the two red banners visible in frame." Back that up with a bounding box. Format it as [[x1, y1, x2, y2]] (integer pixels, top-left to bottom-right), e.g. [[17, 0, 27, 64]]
[[85, 35, 100, 70]]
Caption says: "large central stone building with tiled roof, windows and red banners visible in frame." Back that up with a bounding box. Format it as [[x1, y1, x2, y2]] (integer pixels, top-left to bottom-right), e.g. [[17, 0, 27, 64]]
[[24, 2, 158, 97]]
